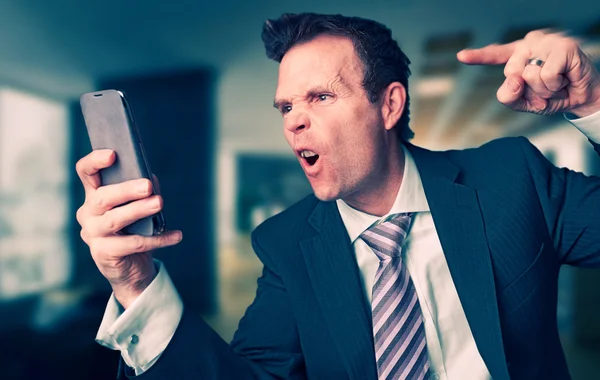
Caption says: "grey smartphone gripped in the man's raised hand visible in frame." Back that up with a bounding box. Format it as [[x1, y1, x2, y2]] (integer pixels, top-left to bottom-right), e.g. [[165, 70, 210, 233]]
[[80, 90, 166, 236]]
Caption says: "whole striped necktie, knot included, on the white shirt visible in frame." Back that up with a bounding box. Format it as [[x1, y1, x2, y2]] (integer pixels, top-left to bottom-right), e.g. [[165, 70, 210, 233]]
[[360, 213, 430, 380]]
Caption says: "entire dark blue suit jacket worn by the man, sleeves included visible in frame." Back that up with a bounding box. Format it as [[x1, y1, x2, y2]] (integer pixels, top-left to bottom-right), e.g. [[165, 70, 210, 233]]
[[119, 138, 600, 380]]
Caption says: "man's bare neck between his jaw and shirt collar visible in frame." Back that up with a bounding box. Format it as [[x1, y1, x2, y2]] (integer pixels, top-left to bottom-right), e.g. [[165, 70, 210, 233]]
[[342, 143, 406, 216]]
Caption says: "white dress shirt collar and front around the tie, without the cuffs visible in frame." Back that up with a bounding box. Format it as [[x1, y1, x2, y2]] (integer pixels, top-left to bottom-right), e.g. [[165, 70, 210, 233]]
[[336, 148, 491, 380]]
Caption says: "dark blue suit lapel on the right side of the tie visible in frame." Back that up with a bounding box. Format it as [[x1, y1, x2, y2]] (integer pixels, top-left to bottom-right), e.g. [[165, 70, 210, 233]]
[[408, 144, 509, 380]]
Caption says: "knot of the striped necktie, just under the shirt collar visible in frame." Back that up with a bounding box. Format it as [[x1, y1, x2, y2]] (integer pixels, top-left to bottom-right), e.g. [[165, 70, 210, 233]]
[[360, 213, 412, 260]]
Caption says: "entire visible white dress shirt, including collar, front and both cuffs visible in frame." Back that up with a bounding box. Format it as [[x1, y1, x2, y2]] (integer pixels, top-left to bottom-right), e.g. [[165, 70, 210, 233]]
[[96, 111, 600, 380]]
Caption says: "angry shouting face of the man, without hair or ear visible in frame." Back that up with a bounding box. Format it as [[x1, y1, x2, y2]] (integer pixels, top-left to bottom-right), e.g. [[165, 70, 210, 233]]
[[275, 36, 386, 201]]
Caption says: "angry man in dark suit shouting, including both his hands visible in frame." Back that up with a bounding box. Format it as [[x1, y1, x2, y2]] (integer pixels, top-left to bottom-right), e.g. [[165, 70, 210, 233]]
[[77, 14, 600, 380]]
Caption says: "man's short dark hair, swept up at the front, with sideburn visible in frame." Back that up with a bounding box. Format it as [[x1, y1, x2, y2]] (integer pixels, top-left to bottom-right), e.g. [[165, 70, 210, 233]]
[[262, 13, 414, 141]]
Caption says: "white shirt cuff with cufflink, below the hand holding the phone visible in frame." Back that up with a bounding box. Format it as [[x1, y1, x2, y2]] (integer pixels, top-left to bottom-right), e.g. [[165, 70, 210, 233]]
[[96, 260, 183, 375]]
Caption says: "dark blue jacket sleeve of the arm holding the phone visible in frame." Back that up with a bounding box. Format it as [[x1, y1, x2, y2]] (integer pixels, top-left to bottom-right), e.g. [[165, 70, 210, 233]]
[[118, 233, 306, 380]]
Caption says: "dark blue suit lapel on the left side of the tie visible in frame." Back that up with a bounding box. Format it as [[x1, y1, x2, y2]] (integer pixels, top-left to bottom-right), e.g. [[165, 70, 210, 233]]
[[300, 202, 377, 380]]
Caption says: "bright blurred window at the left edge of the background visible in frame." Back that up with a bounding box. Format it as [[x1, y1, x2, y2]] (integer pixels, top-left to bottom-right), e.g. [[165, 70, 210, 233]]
[[0, 89, 70, 300]]
